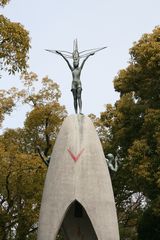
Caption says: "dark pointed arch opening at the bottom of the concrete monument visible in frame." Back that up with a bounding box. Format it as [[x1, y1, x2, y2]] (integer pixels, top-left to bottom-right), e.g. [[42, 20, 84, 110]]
[[57, 201, 98, 240]]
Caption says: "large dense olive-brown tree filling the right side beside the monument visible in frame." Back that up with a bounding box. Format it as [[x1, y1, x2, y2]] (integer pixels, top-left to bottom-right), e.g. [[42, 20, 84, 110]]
[[96, 27, 160, 239]]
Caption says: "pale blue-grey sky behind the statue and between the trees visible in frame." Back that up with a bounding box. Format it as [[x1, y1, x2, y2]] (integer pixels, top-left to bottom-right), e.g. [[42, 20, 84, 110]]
[[0, 0, 160, 129]]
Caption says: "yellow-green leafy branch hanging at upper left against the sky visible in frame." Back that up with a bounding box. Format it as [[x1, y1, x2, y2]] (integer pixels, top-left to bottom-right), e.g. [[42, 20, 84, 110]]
[[0, 14, 30, 74]]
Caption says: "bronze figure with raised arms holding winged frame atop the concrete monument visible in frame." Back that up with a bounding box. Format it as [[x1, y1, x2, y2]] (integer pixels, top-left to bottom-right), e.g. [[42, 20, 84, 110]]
[[46, 39, 106, 114]]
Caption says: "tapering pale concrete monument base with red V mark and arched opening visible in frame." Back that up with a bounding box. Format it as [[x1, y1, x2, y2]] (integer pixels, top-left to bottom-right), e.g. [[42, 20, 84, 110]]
[[38, 115, 119, 240]]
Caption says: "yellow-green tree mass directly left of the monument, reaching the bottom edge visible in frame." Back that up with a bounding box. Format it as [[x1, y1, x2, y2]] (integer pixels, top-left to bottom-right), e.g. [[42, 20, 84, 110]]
[[0, 73, 67, 240]]
